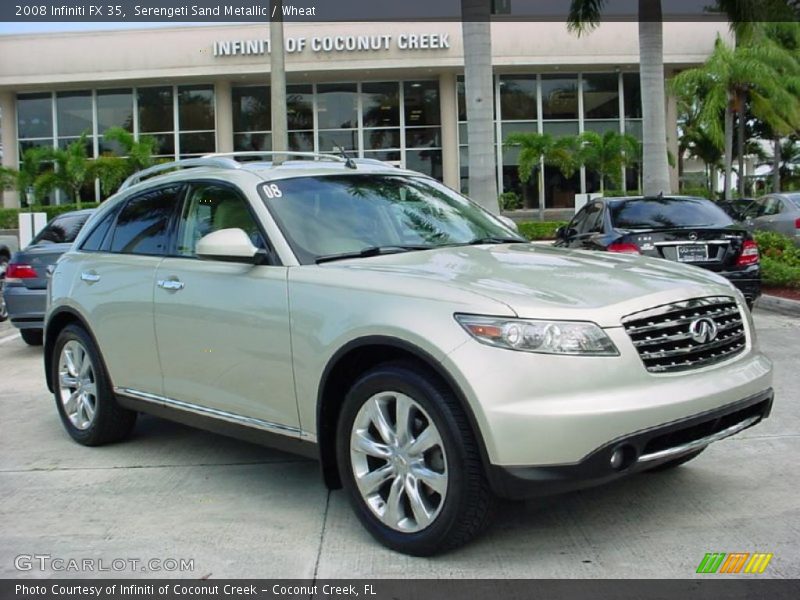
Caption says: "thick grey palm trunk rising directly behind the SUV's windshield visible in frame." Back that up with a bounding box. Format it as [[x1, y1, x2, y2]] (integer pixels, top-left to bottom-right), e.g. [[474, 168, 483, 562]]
[[461, 0, 500, 214]]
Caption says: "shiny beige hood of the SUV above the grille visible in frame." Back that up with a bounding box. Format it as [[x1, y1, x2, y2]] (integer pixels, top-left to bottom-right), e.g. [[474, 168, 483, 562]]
[[324, 244, 734, 327]]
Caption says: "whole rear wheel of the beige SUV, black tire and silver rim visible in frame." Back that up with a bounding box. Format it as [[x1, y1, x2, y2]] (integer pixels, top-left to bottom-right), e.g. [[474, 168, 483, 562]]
[[51, 325, 136, 446]]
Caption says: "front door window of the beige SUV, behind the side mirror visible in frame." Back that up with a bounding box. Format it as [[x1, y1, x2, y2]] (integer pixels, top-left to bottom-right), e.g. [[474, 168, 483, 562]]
[[177, 184, 266, 256]]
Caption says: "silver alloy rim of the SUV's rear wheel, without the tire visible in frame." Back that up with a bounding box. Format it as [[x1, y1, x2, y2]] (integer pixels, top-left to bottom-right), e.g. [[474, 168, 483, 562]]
[[58, 340, 97, 430]]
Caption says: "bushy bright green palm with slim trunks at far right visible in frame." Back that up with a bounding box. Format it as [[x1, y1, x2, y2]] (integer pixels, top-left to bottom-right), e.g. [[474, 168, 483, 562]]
[[673, 37, 800, 200]]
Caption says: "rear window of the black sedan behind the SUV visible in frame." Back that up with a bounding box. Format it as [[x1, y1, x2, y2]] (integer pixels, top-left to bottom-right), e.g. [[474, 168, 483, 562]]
[[609, 198, 733, 229]]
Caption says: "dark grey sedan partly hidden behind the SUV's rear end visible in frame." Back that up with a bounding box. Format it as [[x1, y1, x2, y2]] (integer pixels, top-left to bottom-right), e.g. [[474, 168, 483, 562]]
[[3, 210, 93, 346]]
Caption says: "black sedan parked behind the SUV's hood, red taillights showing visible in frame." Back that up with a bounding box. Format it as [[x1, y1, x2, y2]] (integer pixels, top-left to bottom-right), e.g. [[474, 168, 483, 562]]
[[555, 196, 761, 307]]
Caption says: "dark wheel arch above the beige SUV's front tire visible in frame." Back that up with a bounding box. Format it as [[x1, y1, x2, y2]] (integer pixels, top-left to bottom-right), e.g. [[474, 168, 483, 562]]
[[316, 335, 489, 489]]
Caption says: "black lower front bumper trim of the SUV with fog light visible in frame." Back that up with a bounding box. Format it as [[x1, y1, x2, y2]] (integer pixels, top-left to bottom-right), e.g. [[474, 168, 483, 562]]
[[488, 389, 773, 499]]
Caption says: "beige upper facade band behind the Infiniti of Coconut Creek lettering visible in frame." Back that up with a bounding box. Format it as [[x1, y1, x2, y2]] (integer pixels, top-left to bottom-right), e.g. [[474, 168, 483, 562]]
[[0, 23, 728, 91]]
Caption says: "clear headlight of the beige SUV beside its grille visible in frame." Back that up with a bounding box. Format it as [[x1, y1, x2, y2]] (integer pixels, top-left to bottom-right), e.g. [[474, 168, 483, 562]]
[[455, 314, 619, 356]]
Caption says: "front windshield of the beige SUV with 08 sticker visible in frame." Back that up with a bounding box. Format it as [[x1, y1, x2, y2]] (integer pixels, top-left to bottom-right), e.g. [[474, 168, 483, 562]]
[[261, 174, 522, 264]]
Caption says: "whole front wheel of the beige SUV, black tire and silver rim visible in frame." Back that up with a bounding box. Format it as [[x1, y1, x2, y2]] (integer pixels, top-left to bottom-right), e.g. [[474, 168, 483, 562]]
[[336, 362, 493, 556]]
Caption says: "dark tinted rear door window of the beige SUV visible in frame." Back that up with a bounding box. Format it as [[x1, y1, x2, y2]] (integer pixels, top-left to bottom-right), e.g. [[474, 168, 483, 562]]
[[111, 186, 180, 255]]
